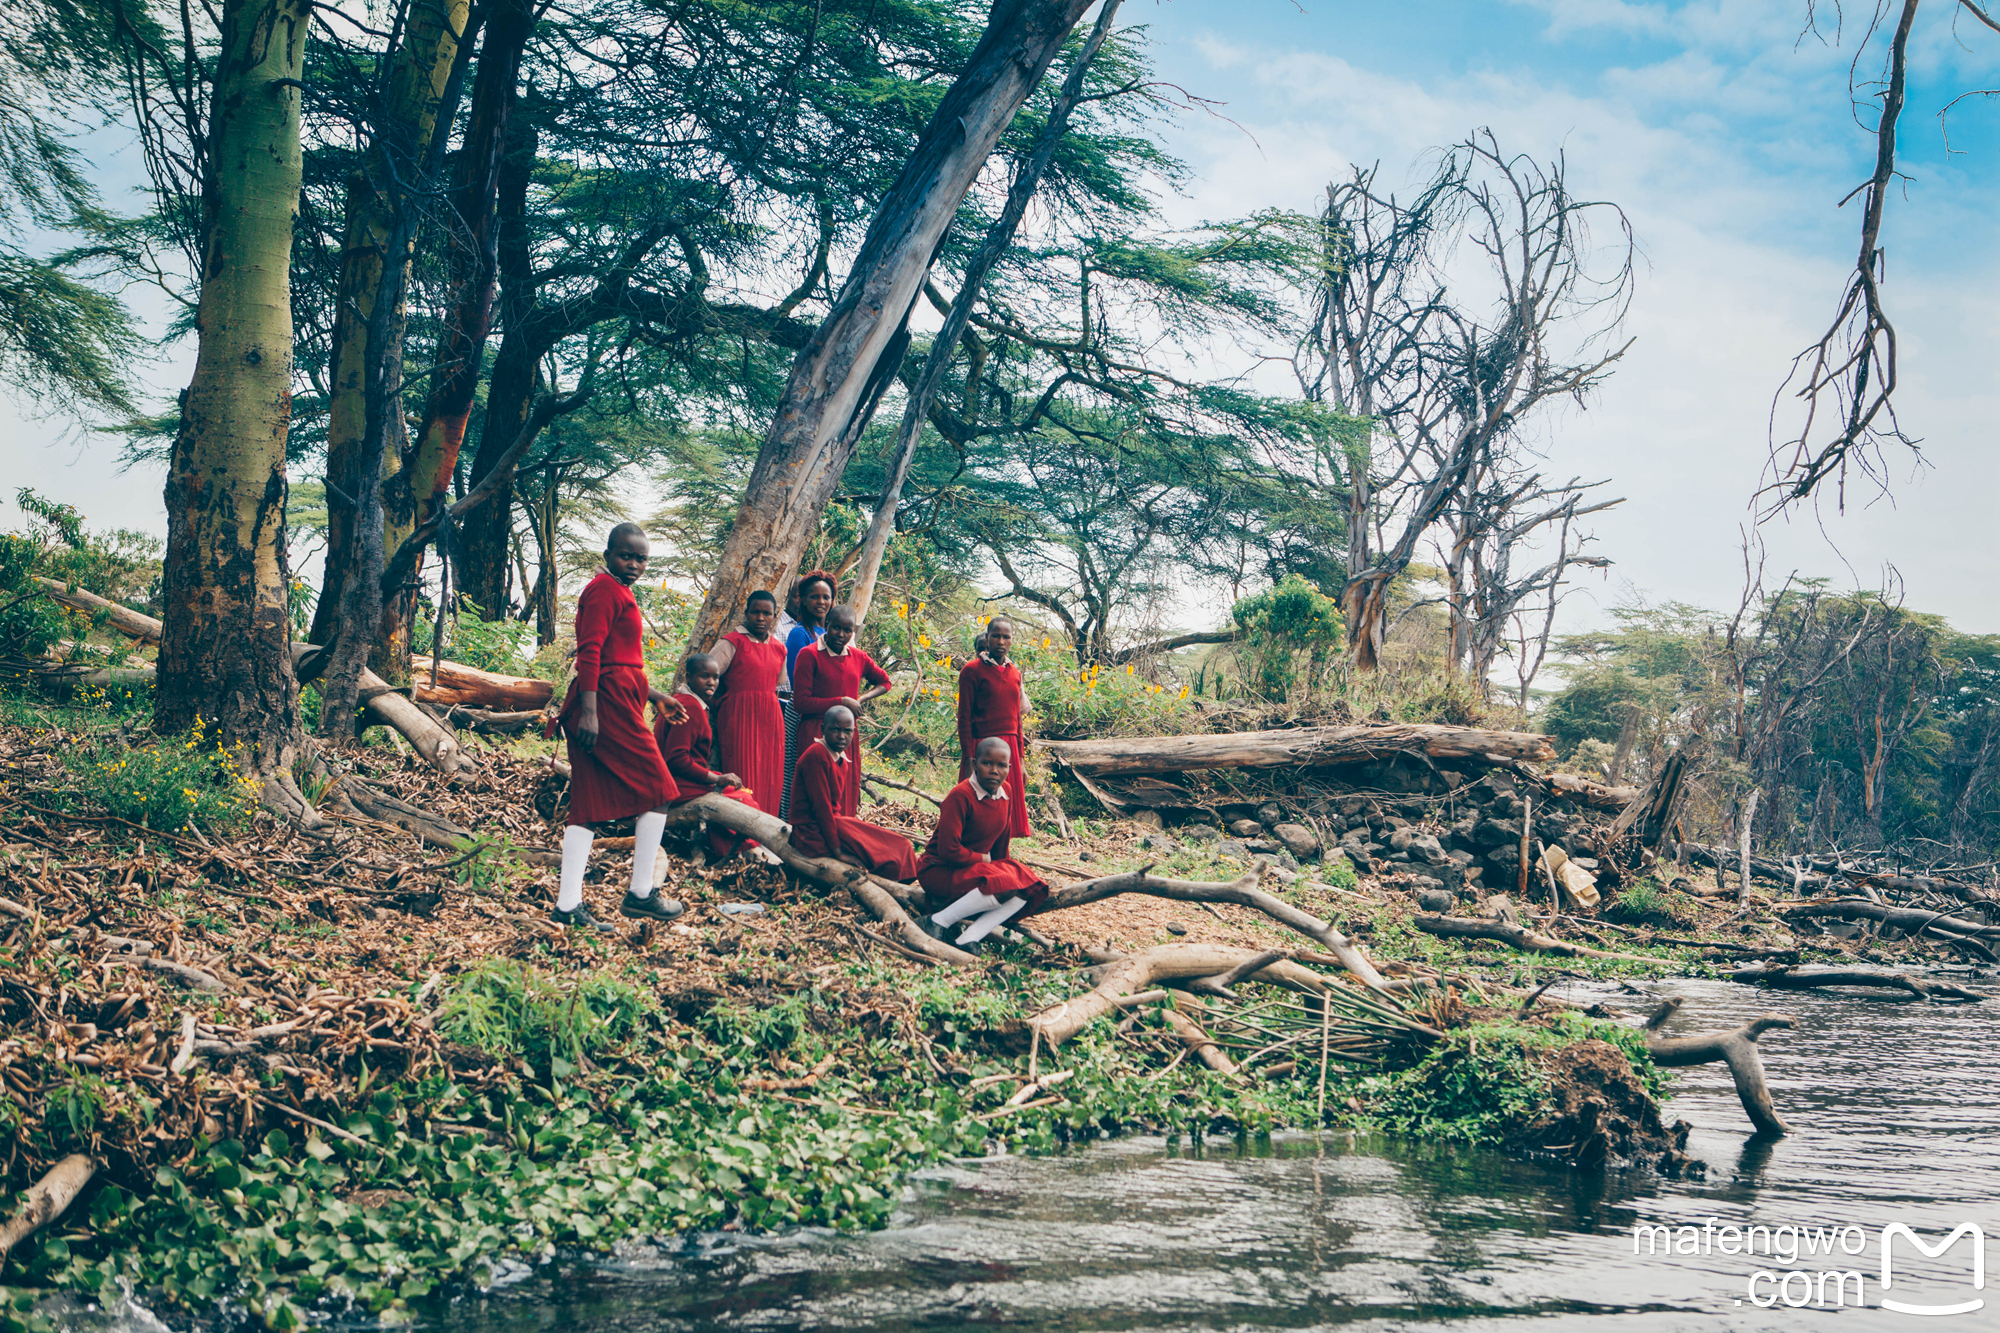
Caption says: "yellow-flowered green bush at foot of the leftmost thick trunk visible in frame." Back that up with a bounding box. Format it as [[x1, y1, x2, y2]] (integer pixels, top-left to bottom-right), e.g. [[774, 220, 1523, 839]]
[[62, 719, 262, 833]]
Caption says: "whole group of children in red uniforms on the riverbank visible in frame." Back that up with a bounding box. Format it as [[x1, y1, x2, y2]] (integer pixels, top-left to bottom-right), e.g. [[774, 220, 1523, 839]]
[[552, 522, 1048, 947]]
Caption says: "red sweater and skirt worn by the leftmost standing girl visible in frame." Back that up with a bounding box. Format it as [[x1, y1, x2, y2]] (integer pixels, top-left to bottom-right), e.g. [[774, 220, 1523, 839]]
[[558, 572, 674, 825]]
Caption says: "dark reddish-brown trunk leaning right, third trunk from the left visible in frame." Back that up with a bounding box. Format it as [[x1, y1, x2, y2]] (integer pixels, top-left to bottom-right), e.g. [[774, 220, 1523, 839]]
[[378, 0, 536, 681]]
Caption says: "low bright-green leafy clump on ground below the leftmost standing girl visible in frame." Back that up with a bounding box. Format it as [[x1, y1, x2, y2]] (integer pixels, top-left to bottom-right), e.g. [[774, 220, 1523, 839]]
[[438, 959, 654, 1077]]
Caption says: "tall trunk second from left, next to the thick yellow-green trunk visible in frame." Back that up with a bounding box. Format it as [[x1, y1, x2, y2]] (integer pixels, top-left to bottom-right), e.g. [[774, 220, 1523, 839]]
[[312, 0, 470, 644]]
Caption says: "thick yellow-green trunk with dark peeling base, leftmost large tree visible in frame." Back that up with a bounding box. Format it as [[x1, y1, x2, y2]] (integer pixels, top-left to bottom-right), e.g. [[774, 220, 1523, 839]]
[[154, 0, 312, 792]]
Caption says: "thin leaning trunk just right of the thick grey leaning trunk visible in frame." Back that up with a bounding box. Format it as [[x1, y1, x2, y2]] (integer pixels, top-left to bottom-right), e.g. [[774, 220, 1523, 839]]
[[848, 0, 1120, 620]]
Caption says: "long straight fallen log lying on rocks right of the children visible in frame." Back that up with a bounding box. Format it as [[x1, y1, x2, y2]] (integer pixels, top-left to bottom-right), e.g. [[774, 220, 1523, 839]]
[[1040, 725, 1556, 777]]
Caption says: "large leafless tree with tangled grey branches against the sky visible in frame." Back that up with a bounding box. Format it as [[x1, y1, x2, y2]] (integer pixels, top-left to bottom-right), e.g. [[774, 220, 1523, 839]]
[[1294, 130, 1632, 669]]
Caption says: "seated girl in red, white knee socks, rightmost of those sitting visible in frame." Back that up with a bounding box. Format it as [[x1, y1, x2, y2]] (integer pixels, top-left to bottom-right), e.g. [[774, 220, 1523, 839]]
[[916, 737, 1048, 947]]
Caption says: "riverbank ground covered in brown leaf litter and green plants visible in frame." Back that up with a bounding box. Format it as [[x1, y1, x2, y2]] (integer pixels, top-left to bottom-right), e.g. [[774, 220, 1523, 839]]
[[0, 715, 1976, 1329]]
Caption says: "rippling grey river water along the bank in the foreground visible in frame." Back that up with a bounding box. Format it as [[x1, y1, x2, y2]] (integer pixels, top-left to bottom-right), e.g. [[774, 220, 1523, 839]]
[[406, 981, 2000, 1333]]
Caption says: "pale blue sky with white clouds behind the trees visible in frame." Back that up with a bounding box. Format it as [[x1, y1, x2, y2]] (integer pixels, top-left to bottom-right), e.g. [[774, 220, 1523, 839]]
[[0, 0, 2000, 632]]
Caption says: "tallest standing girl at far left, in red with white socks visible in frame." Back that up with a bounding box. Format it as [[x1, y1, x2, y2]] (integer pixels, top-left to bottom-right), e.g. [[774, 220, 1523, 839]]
[[552, 522, 682, 933]]
